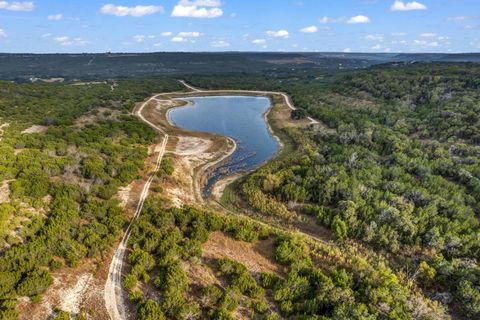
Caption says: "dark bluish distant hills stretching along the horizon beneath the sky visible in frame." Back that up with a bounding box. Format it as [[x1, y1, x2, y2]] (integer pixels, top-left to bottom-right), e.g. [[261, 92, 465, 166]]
[[0, 52, 480, 82]]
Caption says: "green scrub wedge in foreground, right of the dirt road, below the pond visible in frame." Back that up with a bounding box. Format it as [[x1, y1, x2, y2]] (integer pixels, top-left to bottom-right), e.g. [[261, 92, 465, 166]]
[[123, 198, 446, 319]]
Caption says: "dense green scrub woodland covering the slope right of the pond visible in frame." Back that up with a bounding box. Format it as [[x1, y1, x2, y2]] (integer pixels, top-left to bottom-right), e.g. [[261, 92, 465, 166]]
[[188, 63, 480, 319]]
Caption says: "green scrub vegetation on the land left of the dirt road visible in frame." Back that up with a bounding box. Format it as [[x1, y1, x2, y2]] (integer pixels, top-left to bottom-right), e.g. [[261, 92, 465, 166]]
[[0, 79, 179, 319]]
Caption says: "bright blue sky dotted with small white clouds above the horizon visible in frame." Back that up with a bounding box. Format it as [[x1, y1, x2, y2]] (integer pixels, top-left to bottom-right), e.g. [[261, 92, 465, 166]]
[[0, 0, 480, 53]]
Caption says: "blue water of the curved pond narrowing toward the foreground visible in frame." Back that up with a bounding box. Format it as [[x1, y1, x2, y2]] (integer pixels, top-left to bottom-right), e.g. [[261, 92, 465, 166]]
[[169, 96, 280, 196]]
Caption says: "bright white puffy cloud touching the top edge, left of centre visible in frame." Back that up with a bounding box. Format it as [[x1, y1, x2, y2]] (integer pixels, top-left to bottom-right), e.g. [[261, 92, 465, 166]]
[[171, 0, 223, 19]]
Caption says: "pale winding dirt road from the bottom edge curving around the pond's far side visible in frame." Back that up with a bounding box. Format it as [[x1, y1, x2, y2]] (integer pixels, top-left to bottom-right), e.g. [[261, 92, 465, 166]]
[[104, 80, 318, 320]]
